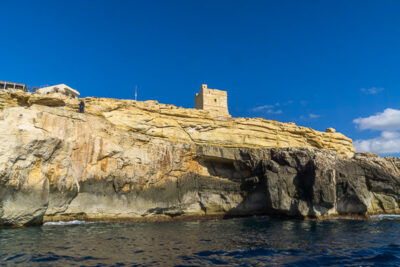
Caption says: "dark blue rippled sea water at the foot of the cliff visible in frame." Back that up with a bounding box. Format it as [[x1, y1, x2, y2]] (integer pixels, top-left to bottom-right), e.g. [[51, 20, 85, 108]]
[[0, 216, 400, 266]]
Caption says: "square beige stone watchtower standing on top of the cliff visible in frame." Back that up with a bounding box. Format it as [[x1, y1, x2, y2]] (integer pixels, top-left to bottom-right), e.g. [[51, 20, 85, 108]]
[[194, 84, 230, 117]]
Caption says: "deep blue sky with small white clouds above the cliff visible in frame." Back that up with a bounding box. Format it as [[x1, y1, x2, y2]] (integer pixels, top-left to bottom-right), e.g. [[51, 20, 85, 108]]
[[0, 0, 400, 155]]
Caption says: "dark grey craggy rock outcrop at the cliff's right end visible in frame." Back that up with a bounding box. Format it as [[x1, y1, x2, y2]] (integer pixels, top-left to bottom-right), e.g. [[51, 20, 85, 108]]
[[230, 148, 400, 218]]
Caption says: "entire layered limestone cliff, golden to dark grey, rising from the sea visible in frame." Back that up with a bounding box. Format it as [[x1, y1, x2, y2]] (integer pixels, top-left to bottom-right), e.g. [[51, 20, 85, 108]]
[[0, 93, 400, 228]]
